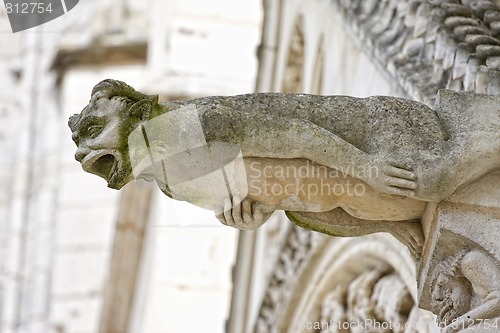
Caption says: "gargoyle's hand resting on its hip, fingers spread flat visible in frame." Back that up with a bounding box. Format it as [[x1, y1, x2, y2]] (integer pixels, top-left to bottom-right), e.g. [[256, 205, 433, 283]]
[[374, 161, 417, 197]]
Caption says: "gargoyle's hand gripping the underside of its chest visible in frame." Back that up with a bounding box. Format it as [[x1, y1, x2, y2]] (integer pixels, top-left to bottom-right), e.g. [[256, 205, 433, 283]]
[[216, 198, 272, 230]]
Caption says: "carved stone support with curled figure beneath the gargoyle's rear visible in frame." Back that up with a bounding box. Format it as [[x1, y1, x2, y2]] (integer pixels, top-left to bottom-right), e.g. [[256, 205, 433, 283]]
[[418, 171, 500, 333]]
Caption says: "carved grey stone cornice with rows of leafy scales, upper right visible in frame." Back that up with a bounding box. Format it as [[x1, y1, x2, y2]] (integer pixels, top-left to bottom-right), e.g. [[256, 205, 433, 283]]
[[332, 0, 500, 104]]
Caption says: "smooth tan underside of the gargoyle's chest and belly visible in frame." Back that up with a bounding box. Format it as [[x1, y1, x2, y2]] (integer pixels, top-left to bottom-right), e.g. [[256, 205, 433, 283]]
[[157, 157, 427, 221]]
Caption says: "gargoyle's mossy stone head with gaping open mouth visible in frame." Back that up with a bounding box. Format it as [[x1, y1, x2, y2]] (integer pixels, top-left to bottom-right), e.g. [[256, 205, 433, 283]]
[[68, 80, 158, 189]]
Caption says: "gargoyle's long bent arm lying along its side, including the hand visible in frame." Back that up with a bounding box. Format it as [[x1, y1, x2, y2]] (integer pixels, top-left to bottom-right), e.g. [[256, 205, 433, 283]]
[[236, 115, 417, 196]]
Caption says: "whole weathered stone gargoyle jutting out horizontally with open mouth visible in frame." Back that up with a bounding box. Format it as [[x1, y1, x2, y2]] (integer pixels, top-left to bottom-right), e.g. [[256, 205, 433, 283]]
[[69, 80, 500, 332]]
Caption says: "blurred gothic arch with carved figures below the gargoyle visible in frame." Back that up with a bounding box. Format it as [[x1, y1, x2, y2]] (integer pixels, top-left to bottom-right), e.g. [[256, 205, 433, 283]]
[[255, 226, 435, 333]]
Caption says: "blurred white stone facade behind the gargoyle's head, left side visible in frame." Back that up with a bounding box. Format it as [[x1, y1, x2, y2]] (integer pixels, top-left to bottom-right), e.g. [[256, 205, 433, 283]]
[[0, 0, 261, 333]]
